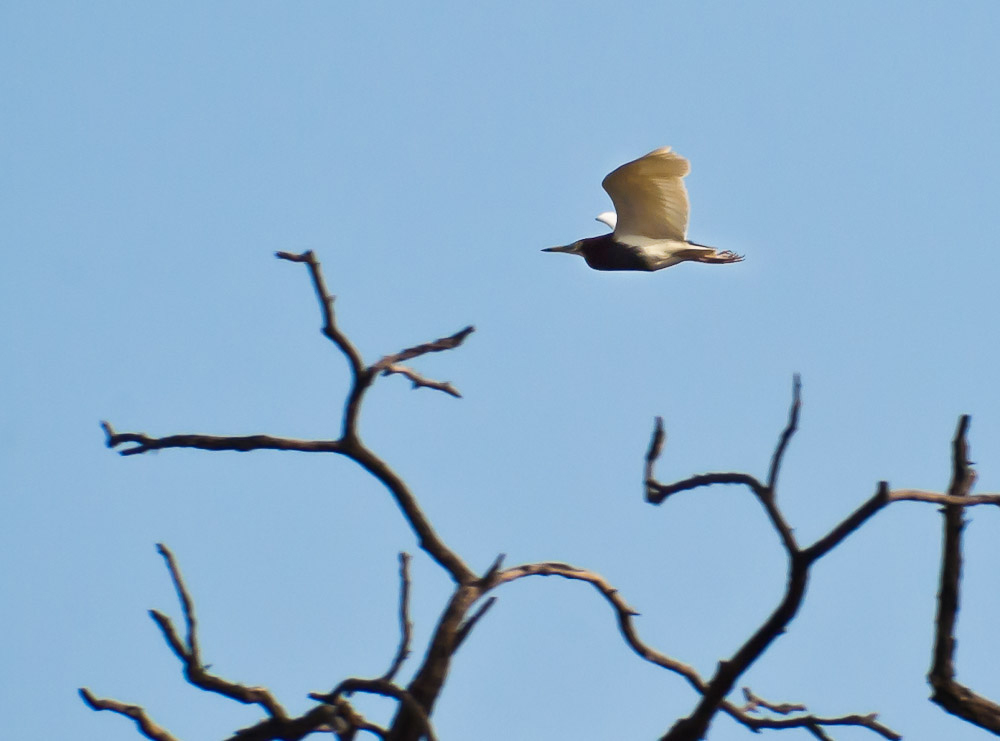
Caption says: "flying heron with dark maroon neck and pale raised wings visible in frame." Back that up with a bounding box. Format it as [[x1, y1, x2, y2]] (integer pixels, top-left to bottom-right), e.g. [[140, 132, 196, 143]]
[[542, 147, 743, 271]]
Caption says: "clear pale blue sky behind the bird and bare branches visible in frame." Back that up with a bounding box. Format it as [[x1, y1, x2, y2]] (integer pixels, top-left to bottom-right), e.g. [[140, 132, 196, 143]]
[[0, 0, 1000, 741]]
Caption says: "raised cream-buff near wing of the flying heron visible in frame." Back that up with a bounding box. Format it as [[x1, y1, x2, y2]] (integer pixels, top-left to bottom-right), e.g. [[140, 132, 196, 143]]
[[601, 147, 691, 241]]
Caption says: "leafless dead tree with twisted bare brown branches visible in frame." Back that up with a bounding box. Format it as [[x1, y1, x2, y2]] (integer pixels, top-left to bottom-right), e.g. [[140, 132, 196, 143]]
[[80, 252, 1000, 741]]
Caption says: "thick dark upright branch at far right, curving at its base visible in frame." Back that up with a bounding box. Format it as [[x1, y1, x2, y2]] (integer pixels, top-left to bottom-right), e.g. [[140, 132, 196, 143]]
[[927, 415, 1000, 735]]
